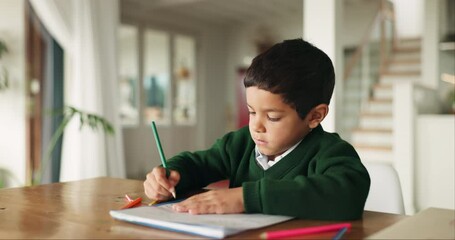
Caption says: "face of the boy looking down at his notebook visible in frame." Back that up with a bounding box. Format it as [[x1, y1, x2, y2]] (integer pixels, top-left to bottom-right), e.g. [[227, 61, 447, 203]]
[[246, 87, 310, 160]]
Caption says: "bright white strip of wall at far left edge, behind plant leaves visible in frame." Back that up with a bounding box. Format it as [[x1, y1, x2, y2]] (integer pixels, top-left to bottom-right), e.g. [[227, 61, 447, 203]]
[[0, 0, 26, 186]]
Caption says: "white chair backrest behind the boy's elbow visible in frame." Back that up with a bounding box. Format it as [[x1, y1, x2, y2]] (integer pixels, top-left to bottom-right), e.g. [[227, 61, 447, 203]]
[[364, 163, 405, 214]]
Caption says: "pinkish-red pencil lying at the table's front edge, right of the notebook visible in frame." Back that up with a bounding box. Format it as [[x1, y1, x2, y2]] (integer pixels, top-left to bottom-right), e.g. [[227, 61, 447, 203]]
[[261, 223, 351, 239]]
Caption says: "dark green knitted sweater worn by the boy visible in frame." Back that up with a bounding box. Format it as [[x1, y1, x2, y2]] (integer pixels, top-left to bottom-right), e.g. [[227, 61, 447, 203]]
[[168, 126, 370, 220]]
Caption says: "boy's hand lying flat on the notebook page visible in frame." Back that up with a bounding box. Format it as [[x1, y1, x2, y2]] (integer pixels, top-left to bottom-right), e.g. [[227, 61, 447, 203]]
[[172, 187, 245, 214]]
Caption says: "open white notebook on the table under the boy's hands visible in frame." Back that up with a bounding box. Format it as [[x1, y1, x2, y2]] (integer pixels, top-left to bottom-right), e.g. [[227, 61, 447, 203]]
[[110, 204, 292, 238]]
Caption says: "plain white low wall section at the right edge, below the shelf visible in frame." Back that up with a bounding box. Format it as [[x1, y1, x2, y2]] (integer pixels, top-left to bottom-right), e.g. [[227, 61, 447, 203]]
[[416, 114, 455, 211]]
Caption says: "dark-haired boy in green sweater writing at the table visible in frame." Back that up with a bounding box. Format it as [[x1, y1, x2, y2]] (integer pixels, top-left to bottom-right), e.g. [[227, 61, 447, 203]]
[[144, 39, 370, 220]]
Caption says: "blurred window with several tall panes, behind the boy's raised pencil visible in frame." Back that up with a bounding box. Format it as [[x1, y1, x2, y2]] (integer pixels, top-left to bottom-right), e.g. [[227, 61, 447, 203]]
[[119, 25, 197, 126]]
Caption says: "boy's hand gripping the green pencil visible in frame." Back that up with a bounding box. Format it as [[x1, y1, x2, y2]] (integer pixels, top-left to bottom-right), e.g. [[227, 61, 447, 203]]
[[144, 166, 180, 201]]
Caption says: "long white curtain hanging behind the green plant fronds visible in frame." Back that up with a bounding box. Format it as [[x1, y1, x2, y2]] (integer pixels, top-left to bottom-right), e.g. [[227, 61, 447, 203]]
[[30, 0, 125, 181]]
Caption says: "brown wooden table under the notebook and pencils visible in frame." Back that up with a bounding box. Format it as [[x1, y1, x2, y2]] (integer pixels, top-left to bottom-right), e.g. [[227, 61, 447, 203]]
[[0, 178, 406, 239]]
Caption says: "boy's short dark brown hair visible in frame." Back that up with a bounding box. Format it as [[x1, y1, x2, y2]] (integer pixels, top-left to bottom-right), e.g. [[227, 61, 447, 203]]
[[243, 38, 335, 119]]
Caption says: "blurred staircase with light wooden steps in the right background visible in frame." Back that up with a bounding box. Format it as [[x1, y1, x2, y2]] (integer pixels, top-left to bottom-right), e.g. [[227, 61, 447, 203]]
[[350, 39, 421, 165]]
